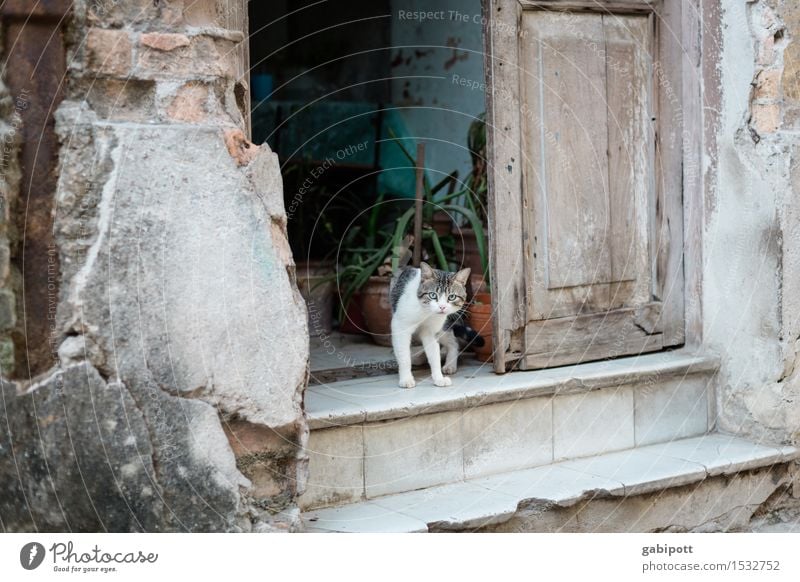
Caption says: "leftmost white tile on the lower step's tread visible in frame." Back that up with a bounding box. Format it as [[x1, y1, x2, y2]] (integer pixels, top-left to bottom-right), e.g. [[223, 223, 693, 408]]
[[303, 502, 428, 533]]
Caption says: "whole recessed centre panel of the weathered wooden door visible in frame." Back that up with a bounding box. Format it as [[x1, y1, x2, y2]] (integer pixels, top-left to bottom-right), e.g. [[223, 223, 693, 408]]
[[521, 11, 651, 320]]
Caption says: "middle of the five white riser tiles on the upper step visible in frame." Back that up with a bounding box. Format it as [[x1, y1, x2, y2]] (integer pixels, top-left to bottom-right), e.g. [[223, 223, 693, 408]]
[[462, 397, 553, 479]]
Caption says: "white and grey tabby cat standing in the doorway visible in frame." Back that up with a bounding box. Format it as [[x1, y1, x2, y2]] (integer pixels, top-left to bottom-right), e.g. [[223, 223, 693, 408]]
[[389, 262, 482, 388]]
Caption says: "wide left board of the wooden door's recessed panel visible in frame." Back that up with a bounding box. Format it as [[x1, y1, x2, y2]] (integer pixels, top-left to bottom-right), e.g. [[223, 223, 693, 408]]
[[520, 10, 611, 290]]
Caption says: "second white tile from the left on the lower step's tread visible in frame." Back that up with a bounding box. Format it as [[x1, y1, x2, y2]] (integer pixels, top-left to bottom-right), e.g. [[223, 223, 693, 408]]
[[372, 483, 517, 529]]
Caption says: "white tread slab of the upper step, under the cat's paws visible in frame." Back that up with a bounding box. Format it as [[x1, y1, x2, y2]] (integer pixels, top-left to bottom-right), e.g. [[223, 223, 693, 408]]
[[305, 351, 719, 430]]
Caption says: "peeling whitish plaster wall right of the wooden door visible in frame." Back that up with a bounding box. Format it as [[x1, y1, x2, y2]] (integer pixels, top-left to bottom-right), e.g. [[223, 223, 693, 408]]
[[703, 0, 800, 444]]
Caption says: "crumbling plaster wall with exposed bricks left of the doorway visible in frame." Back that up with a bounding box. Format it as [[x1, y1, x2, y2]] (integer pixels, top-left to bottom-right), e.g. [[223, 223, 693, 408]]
[[0, 0, 308, 531]]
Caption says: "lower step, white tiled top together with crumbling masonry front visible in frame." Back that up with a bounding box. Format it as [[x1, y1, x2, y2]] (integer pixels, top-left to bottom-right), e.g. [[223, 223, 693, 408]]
[[303, 434, 800, 532]]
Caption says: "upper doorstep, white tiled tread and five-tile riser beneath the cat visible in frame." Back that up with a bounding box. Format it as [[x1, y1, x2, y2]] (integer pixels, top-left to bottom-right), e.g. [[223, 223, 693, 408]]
[[300, 351, 718, 510]]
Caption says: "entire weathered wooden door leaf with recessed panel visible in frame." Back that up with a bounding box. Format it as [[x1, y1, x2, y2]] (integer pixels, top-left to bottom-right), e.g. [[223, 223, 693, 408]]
[[486, 0, 684, 372]]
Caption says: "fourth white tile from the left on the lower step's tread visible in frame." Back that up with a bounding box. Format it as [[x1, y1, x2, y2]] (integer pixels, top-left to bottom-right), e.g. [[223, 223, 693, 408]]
[[561, 449, 706, 495]]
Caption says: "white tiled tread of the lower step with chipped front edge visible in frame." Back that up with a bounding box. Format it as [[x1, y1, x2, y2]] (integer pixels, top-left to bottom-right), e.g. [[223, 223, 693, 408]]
[[303, 434, 800, 532]]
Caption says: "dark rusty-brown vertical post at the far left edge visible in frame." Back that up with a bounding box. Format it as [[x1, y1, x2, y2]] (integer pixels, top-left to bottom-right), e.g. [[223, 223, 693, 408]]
[[2, 12, 68, 378]]
